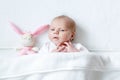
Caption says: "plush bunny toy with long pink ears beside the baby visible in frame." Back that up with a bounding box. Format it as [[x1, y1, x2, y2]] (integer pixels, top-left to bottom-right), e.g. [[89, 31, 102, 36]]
[[10, 22, 49, 55]]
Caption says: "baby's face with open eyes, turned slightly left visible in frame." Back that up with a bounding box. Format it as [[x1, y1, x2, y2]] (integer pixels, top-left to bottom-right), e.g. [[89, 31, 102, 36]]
[[48, 20, 74, 45]]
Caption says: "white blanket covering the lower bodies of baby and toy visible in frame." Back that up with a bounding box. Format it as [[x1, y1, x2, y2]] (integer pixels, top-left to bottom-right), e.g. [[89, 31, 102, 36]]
[[0, 53, 120, 80]]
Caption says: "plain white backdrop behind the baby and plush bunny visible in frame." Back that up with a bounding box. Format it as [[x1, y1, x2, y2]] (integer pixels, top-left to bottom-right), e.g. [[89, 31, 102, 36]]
[[0, 0, 120, 51]]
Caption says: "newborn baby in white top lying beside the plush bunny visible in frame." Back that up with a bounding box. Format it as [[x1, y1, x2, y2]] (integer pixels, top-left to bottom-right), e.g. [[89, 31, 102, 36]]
[[40, 15, 88, 53]]
